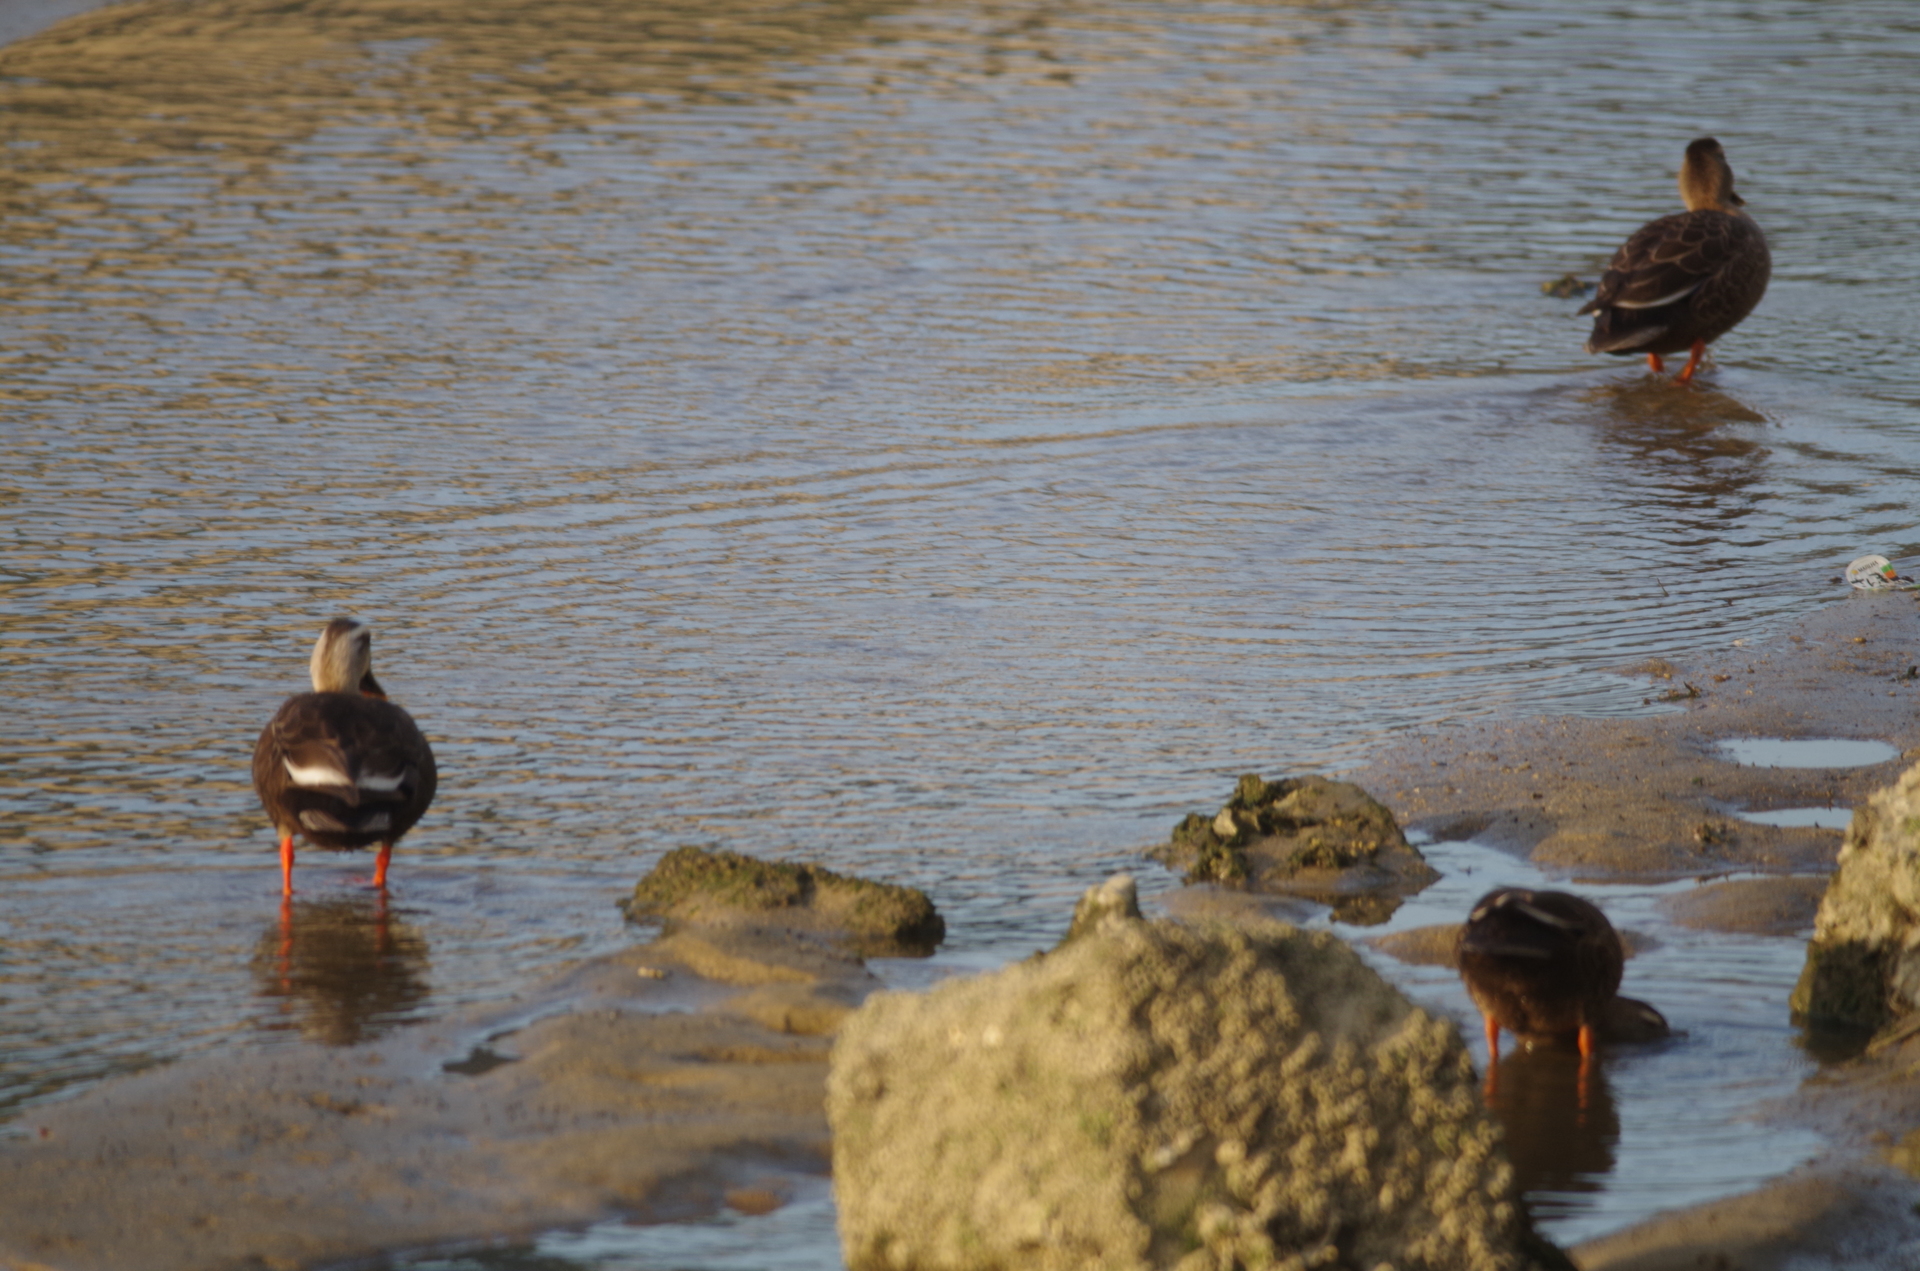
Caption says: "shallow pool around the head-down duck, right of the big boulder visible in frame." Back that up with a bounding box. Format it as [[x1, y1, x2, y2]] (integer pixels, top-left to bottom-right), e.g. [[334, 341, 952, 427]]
[[1319, 843, 1822, 1244]]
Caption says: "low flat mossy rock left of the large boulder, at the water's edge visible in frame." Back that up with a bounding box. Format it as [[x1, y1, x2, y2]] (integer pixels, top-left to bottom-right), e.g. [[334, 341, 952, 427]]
[[622, 847, 947, 956]]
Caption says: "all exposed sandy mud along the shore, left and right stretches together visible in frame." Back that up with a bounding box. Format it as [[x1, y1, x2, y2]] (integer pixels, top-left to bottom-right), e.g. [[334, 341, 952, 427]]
[[0, 595, 1920, 1271]]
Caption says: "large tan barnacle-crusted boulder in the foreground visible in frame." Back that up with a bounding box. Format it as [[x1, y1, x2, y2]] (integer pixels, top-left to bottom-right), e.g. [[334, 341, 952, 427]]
[[828, 894, 1571, 1271]]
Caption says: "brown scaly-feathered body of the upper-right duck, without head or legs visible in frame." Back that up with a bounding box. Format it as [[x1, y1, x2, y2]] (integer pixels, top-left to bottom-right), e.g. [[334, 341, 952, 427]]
[[1580, 209, 1766, 353]]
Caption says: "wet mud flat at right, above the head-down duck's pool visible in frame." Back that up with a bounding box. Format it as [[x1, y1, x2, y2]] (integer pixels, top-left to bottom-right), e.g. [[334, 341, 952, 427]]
[[1344, 593, 1920, 879]]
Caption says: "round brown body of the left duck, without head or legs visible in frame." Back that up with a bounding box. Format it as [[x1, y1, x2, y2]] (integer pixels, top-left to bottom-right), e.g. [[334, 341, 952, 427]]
[[253, 693, 438, 847]]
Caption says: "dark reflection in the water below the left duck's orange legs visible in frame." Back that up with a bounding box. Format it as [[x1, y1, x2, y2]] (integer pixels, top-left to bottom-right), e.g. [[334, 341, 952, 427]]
[[253, 891, 428, 1046]]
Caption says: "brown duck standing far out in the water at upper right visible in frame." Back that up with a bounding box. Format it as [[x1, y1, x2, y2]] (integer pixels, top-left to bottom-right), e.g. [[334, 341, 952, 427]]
[[1580, 136, 1772, 384]]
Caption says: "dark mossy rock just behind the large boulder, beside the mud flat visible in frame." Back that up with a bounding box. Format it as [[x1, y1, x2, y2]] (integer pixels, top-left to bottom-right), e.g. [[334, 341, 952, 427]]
[[1154, 774, 1440, 925]]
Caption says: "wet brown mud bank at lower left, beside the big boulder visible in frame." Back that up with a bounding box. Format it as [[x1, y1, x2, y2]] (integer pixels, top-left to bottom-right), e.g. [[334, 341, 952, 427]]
[[0, 875, 924, 1271]]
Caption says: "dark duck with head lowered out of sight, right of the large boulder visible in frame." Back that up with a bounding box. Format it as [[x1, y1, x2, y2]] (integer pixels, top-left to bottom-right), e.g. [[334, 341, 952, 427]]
[[1455, 887, 1667, 1094]]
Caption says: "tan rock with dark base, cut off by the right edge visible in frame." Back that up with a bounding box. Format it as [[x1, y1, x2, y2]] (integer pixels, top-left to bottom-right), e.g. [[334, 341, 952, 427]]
[[1791, 764, 1920, 1029]]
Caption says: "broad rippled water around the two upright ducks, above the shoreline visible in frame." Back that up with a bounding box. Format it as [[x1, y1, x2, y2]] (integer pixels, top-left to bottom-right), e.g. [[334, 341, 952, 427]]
[[0, 0, 1920, 1251]]
